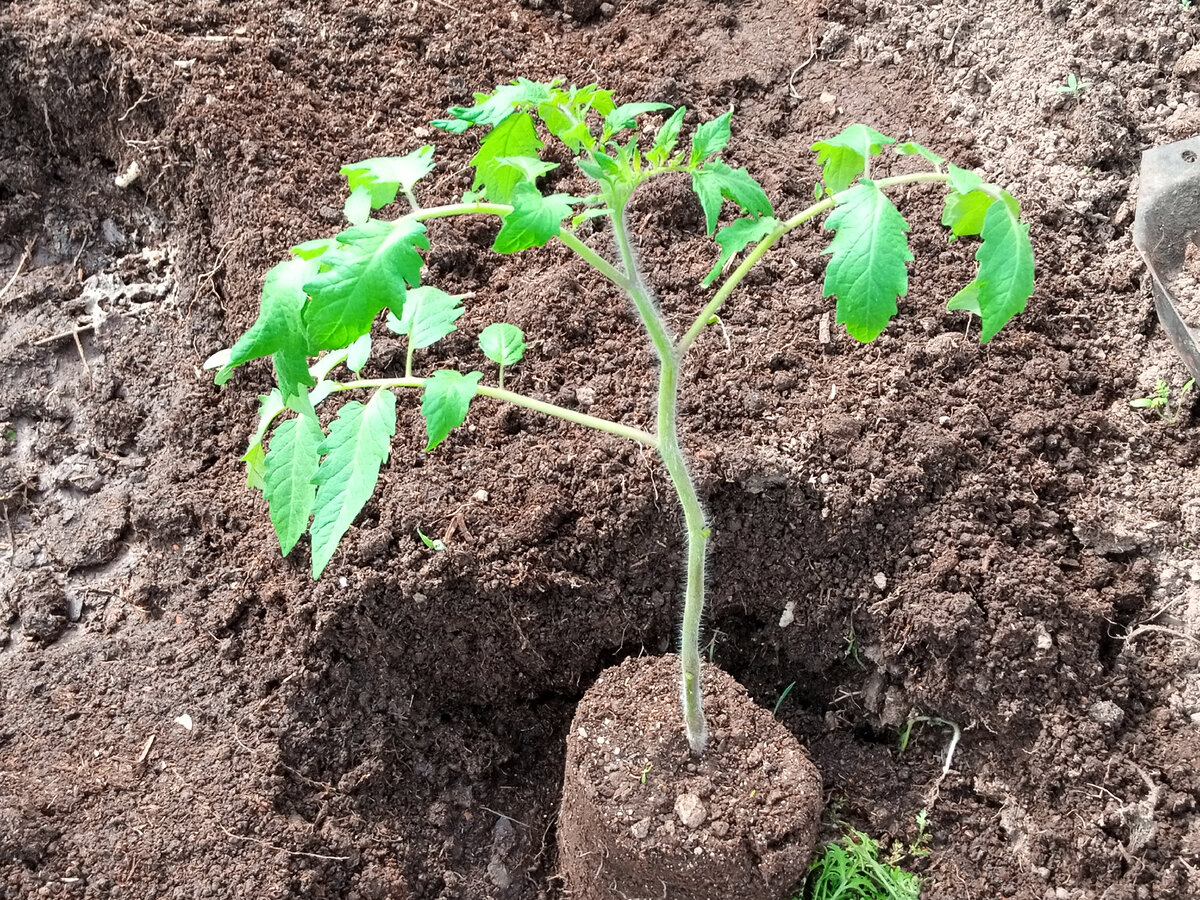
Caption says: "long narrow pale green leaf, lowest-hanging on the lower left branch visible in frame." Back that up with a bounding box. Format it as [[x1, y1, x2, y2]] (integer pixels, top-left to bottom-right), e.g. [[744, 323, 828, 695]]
[[312, 390, 396, 578]]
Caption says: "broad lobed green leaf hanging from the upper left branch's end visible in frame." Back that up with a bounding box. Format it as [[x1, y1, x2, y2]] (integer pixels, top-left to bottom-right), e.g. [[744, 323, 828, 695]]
[[304, 216, 430, 350]]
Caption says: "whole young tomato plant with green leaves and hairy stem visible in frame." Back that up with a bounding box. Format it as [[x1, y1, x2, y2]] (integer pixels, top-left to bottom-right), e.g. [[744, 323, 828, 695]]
[[210, 79, 1033, 754]]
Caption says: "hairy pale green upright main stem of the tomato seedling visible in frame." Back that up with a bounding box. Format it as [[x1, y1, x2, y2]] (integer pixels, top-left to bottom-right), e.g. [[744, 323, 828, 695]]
[[612, 198, 709, 756]]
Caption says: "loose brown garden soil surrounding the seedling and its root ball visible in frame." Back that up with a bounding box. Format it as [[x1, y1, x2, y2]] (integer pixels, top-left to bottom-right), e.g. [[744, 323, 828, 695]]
[[0, 0, 1200, 900]]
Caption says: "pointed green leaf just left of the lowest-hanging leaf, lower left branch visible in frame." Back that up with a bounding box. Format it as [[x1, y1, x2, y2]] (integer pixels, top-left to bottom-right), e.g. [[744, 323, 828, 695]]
[[263, 415, 325, 556]]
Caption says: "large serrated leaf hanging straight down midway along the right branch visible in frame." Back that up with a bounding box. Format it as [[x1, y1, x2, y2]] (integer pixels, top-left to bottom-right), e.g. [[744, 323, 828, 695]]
[[823, 179, 912, 342]]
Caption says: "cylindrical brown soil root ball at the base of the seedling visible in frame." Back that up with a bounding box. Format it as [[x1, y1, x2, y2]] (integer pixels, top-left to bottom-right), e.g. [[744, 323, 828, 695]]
[[558, 654, 822, 900]]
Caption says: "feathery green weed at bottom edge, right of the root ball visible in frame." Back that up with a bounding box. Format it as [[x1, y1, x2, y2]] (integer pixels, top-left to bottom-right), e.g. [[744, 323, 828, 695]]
[[796, 825, 929, 900]]
